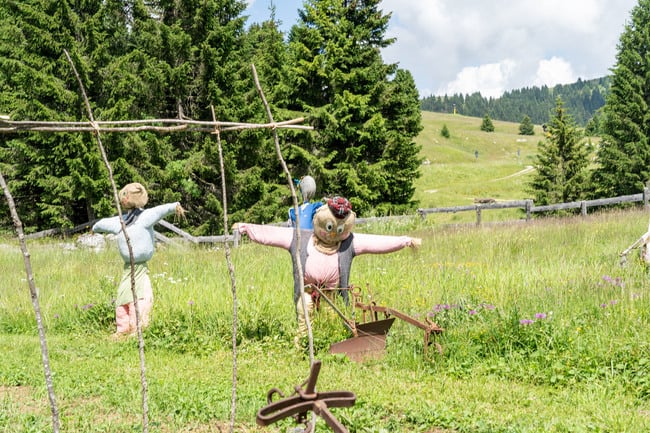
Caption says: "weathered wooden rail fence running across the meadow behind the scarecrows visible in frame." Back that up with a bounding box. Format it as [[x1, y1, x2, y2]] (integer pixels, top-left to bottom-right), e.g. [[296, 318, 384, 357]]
[[25, 188, 650, 247]]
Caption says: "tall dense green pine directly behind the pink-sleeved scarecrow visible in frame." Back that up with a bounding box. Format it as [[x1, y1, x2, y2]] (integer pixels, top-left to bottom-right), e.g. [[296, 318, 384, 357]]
[[286, 0, 422, 214]]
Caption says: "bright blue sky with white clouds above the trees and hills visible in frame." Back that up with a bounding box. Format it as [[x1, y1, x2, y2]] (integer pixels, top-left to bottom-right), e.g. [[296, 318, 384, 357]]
[[245, 0, 638, 97]]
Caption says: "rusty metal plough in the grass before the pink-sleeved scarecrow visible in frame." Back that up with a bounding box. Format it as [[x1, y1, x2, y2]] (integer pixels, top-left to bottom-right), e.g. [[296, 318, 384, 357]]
[[314, 287, 444, 361]]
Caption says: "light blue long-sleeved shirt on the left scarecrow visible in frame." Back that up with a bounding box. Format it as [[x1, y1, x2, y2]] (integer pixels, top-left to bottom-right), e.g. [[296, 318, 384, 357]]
[[92, 202, 179, 263]]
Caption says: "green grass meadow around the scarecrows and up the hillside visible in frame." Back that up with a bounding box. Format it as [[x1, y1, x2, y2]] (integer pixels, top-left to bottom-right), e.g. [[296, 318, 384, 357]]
[[0, 113, 650, 433]]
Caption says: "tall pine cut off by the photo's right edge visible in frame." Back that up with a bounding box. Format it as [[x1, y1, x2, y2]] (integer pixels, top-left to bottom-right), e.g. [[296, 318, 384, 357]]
[[593, 0, 650, 197]]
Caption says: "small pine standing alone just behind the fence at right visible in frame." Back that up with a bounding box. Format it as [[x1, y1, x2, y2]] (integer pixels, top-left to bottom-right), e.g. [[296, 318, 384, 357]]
[[528, 98, 589, 205]]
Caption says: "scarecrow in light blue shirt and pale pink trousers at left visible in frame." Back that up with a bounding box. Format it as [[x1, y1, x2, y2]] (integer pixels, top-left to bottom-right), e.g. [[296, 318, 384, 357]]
[[92, 183, 185, 337]]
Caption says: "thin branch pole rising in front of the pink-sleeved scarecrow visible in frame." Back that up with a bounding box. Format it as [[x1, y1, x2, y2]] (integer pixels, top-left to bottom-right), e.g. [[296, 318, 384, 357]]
[[251, 64, 314, 367]]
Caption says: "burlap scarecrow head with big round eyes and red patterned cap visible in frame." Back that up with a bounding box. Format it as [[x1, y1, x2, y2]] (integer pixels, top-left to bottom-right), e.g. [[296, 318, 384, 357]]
[[314, 197, 356, 254]]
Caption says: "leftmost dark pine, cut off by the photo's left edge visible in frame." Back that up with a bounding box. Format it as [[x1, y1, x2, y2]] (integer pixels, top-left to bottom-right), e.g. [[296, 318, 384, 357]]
[[0, 0, 105, 232]]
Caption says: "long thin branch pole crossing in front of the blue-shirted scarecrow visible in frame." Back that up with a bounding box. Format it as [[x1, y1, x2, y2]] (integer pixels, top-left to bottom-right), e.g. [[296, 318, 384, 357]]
[[63, 50, 149, 433]]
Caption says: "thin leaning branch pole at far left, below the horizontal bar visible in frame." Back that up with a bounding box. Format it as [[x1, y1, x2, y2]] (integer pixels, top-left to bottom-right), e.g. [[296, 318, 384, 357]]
[[0, 172, 61, 433]]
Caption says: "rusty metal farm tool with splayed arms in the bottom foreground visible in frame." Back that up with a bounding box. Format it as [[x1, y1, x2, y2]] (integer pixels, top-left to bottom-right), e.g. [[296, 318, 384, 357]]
[[256, 361, 357, 433]]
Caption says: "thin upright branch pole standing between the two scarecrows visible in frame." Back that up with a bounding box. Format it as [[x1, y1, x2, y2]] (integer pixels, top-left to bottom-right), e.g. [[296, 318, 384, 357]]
[[210, 105, 237, 433]]
